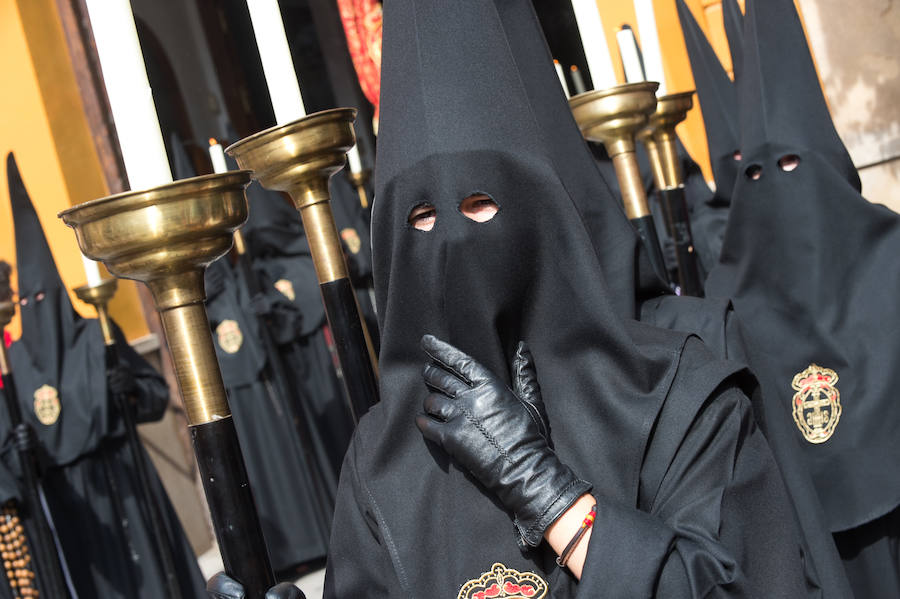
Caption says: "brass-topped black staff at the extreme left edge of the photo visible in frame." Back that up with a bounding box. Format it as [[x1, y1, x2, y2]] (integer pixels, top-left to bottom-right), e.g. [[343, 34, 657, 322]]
[[0, 300, 75, 599]]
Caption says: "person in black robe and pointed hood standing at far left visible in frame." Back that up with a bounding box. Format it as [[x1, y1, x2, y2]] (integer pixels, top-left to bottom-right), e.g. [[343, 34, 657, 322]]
[[0, 154, 203, 599]]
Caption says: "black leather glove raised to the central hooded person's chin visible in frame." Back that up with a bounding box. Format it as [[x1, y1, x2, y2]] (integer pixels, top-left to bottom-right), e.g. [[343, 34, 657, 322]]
[[416, 335, 591, 548]]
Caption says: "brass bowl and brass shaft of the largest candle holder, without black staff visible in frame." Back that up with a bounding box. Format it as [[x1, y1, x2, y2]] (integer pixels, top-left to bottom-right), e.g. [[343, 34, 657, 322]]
[[59, 171, 250, 424]]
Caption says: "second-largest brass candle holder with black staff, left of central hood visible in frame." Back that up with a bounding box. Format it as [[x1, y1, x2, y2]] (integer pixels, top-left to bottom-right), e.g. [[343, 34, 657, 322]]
[[225, 108, 378, 420]]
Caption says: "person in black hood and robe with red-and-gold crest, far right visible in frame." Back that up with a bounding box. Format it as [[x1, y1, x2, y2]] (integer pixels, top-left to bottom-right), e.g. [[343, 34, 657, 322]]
[[706, 0, 900, 597]]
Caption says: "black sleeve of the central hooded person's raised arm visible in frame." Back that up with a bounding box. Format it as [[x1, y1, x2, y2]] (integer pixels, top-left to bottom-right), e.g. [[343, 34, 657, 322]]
[[577, 387, 807, 598]]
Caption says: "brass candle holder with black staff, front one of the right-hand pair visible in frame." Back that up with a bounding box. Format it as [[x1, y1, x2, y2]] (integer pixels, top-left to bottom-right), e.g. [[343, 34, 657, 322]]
[[569, 81, 669, 282]]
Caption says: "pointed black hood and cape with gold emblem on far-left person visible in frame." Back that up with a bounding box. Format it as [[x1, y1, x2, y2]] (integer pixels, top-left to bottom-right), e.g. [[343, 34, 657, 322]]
[[6, 154, 108, 465]]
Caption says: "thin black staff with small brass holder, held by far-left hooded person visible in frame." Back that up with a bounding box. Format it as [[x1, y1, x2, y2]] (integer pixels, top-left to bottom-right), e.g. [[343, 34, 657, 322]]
[[74, 276, 181, 599]]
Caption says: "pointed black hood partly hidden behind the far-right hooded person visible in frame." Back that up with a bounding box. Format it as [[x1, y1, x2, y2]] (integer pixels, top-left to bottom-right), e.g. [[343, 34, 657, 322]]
[[678, 0, 739, 202]]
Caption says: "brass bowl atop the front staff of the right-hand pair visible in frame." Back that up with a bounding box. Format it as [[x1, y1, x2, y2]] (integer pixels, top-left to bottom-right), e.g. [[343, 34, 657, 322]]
[[569, 81, 659, 156]]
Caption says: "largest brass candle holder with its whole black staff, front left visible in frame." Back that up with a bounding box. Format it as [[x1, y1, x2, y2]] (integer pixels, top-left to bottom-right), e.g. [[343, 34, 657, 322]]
[[60, 171, 275, 599]]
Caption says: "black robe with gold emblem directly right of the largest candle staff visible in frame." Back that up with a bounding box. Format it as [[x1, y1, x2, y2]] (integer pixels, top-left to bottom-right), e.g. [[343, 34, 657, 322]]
[[206, 259, 331, 572]]
